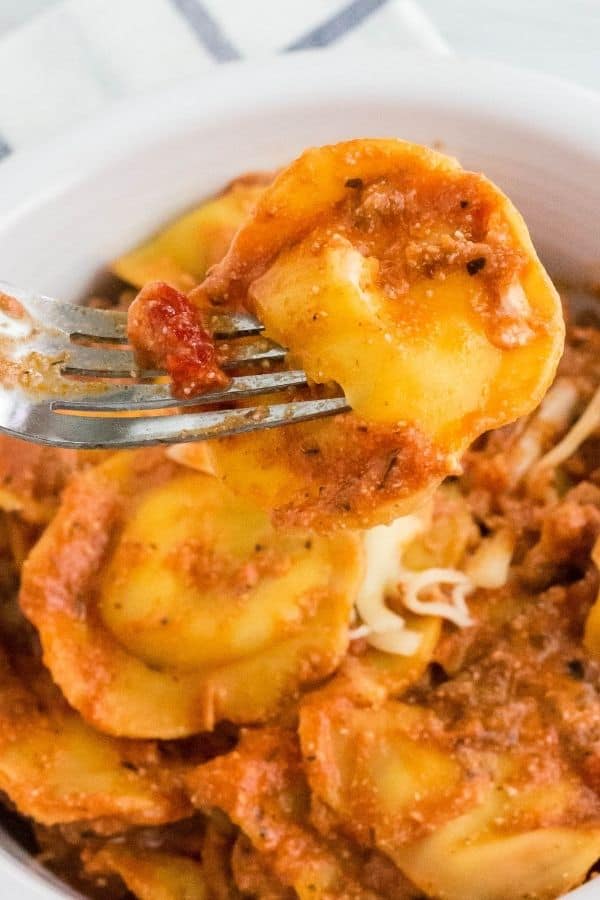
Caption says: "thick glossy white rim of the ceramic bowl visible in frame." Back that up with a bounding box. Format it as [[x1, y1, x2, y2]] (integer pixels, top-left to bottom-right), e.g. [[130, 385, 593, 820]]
[[0, 49, 600, 900]]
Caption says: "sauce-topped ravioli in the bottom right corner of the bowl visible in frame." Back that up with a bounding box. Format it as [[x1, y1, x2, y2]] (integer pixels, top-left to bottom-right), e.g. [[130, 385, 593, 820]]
[[300, 692, 600, 900]]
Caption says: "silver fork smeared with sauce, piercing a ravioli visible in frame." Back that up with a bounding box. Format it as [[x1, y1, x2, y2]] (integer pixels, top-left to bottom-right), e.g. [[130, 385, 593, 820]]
[[0, 282, 349, 449]]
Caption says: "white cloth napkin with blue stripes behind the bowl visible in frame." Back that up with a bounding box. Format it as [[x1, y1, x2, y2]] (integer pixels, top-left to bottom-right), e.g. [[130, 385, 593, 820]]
[[0, 0, 447, 158]]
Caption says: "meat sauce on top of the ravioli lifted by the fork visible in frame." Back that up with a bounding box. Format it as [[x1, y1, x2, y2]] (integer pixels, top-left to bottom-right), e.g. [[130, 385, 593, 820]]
[[326, 173, 532, 346]]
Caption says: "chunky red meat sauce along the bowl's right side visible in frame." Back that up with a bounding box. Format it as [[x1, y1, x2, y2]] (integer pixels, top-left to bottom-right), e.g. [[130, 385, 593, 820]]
[[406, 318, 600, 808]]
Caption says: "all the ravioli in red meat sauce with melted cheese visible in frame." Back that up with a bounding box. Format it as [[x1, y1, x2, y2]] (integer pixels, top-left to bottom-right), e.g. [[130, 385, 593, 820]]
[[0, 140, 600, 900]]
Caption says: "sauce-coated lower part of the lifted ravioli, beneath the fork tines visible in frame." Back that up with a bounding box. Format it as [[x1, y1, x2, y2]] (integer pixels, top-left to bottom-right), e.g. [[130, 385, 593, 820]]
[[173, 416, 450, 533]]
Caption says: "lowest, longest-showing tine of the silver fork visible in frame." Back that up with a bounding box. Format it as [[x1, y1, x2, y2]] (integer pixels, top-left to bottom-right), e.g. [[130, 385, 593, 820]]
[[2, 397, 349, 450]]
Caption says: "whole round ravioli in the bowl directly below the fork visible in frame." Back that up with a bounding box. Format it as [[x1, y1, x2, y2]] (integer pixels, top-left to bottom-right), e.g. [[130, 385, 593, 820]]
[[20, 450, 362, 738]]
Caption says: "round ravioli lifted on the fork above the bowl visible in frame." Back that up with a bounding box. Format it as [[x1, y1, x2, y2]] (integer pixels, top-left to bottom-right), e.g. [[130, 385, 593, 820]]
[[178, 140, 564, 528]]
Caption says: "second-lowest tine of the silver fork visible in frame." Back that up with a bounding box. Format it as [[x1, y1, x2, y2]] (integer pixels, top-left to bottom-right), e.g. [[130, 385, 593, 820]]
[[54, 370, 307, 412]]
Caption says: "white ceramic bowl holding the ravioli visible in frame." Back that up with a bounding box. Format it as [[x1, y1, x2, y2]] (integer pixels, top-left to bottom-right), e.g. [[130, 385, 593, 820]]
[[0, 53, 600, 900]]
